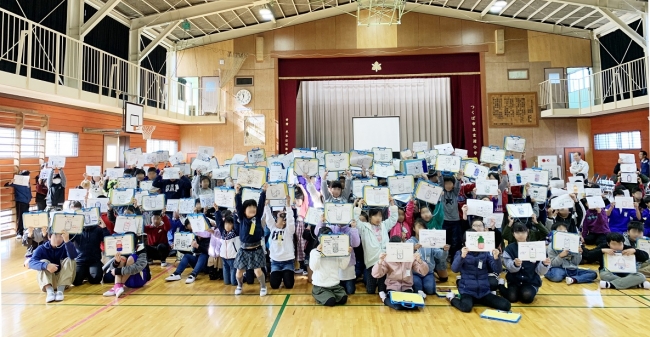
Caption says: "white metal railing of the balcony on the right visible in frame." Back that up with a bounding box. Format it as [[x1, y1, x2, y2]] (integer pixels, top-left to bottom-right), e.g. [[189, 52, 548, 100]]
[[538, 57, 648, 110]]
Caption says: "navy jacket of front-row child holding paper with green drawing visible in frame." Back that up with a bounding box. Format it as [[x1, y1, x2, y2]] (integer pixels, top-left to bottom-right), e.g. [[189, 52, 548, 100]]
[[451, 251, 501, 298]]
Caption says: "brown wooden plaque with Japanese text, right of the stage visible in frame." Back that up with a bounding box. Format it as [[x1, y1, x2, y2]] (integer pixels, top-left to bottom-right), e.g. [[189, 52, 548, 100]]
[[488, 92, 539, 127]]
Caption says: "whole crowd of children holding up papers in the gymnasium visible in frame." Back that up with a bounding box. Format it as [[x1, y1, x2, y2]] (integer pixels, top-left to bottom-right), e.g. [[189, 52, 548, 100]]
[[5, 147, 650, 312]]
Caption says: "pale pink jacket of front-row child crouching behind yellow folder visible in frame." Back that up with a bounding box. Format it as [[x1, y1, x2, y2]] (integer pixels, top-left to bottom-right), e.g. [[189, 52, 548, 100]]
[[372, 260, 429, 291]]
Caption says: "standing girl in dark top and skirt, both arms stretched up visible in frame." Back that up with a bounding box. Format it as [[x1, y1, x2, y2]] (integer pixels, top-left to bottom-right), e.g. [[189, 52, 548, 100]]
[[234, 184, 267, 296]]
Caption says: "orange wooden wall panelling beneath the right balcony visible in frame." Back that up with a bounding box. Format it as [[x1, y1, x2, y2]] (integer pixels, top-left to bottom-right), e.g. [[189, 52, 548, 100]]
[[591, 109, 650, 175]]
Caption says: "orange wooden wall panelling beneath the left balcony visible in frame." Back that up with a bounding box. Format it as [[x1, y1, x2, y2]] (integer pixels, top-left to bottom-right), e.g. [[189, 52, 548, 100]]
[[0, 97, 180, 200]]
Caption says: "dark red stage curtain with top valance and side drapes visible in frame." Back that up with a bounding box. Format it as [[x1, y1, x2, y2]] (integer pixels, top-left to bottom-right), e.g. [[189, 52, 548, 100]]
[[278, 53, 483, 157]]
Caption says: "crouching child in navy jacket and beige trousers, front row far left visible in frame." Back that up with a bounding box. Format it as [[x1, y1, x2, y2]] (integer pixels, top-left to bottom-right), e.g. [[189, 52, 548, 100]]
[[29, 231, 77, 303]]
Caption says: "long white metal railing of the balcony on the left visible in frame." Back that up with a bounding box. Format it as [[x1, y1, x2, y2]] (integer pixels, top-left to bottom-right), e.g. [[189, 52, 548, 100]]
[[0, 8, 220, 115]]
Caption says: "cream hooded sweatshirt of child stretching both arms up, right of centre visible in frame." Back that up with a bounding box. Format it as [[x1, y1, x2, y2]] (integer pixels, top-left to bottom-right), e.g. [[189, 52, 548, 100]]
[[354, 206, 397, 268]]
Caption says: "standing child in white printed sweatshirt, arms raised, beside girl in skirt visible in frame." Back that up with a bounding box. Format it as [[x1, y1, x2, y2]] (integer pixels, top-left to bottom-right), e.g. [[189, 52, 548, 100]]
[[264, 196, 296, 289]]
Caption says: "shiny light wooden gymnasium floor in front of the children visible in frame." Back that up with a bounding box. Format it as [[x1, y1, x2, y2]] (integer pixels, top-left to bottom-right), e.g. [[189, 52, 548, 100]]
[[0, 238, 650, 337]]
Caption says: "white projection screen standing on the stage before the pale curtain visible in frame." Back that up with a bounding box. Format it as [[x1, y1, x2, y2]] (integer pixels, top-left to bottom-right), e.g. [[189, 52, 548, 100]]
[[352, 116, 401, 152]]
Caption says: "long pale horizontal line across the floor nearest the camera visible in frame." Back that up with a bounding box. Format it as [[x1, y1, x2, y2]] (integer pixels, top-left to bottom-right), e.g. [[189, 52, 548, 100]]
[[2, 295, 650, 308]]
